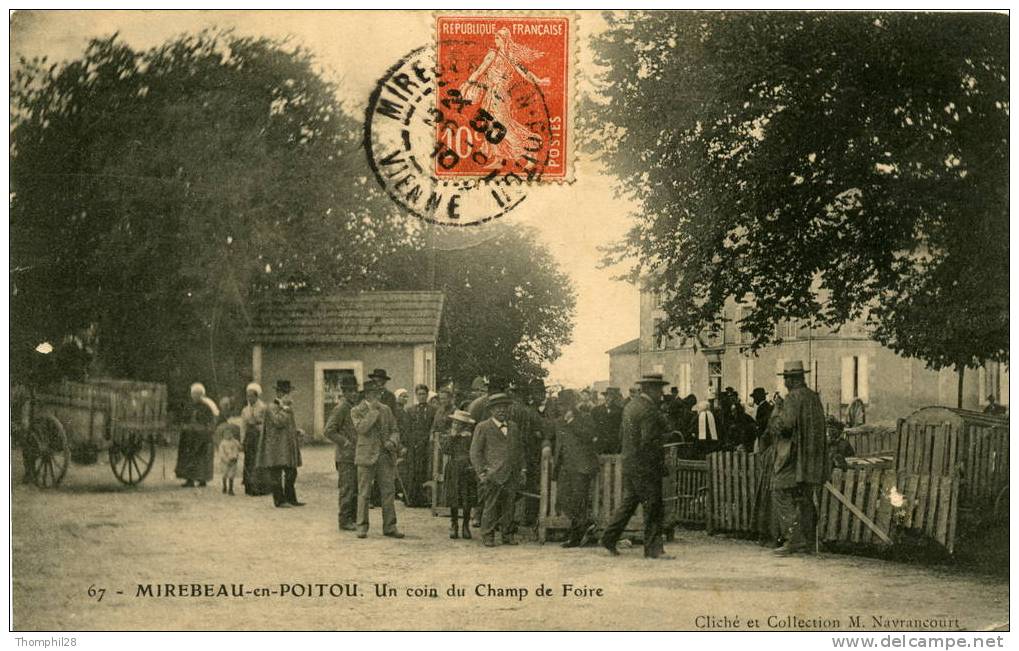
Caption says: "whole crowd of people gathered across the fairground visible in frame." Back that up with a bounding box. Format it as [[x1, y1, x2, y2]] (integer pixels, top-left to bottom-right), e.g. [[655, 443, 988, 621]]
[[176, 362, 839, 558]]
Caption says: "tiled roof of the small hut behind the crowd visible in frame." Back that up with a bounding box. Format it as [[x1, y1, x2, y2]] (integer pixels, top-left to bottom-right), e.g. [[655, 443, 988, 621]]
[[249, 291, 444, 343]]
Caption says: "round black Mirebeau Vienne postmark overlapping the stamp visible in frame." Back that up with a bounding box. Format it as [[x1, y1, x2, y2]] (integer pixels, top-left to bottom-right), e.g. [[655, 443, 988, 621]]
[[364, 42, 549, 226]]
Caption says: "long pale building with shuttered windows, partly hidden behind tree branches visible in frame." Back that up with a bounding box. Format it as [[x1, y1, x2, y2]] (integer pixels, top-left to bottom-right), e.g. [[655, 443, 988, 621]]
[[638, 291, 1009, 424]]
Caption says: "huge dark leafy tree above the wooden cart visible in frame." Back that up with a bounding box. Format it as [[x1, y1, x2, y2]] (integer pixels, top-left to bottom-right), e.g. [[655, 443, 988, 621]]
[[10, 33, 413, 399]]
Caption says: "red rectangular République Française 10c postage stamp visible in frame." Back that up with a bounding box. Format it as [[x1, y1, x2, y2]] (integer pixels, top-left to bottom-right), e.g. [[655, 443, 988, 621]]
[[434, 15, 573, 182]]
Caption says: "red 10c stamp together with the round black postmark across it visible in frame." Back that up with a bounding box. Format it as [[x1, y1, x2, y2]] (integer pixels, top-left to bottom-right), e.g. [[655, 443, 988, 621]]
[[365, 14, 572, 226]]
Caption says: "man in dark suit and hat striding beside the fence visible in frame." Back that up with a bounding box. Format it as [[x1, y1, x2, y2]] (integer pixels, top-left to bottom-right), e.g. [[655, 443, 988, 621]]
[[601, 373, 668, 558]]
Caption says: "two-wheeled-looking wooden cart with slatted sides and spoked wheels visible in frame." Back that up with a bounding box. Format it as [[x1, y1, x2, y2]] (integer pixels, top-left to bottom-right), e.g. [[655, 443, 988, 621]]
[[21, 380, 166, 488]]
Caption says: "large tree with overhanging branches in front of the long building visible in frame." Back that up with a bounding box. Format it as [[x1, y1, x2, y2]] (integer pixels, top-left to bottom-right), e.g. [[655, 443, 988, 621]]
[[586, 12, 1009, 403]]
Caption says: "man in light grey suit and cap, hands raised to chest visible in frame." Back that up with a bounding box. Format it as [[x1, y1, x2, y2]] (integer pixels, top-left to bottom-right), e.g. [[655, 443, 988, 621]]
[[351, 380, 404, 538]]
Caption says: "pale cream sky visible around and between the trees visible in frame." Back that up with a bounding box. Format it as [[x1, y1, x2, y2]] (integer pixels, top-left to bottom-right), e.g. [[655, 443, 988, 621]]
[[10, 10, 639, 386]]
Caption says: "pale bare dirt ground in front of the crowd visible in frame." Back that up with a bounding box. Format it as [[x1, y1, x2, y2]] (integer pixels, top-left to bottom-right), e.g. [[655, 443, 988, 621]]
[[12, 447, 1008, 631]]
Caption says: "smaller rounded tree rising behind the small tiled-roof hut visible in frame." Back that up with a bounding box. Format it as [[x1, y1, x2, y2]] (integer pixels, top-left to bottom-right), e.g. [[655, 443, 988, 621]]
[[383, 227, 576, 386]]
